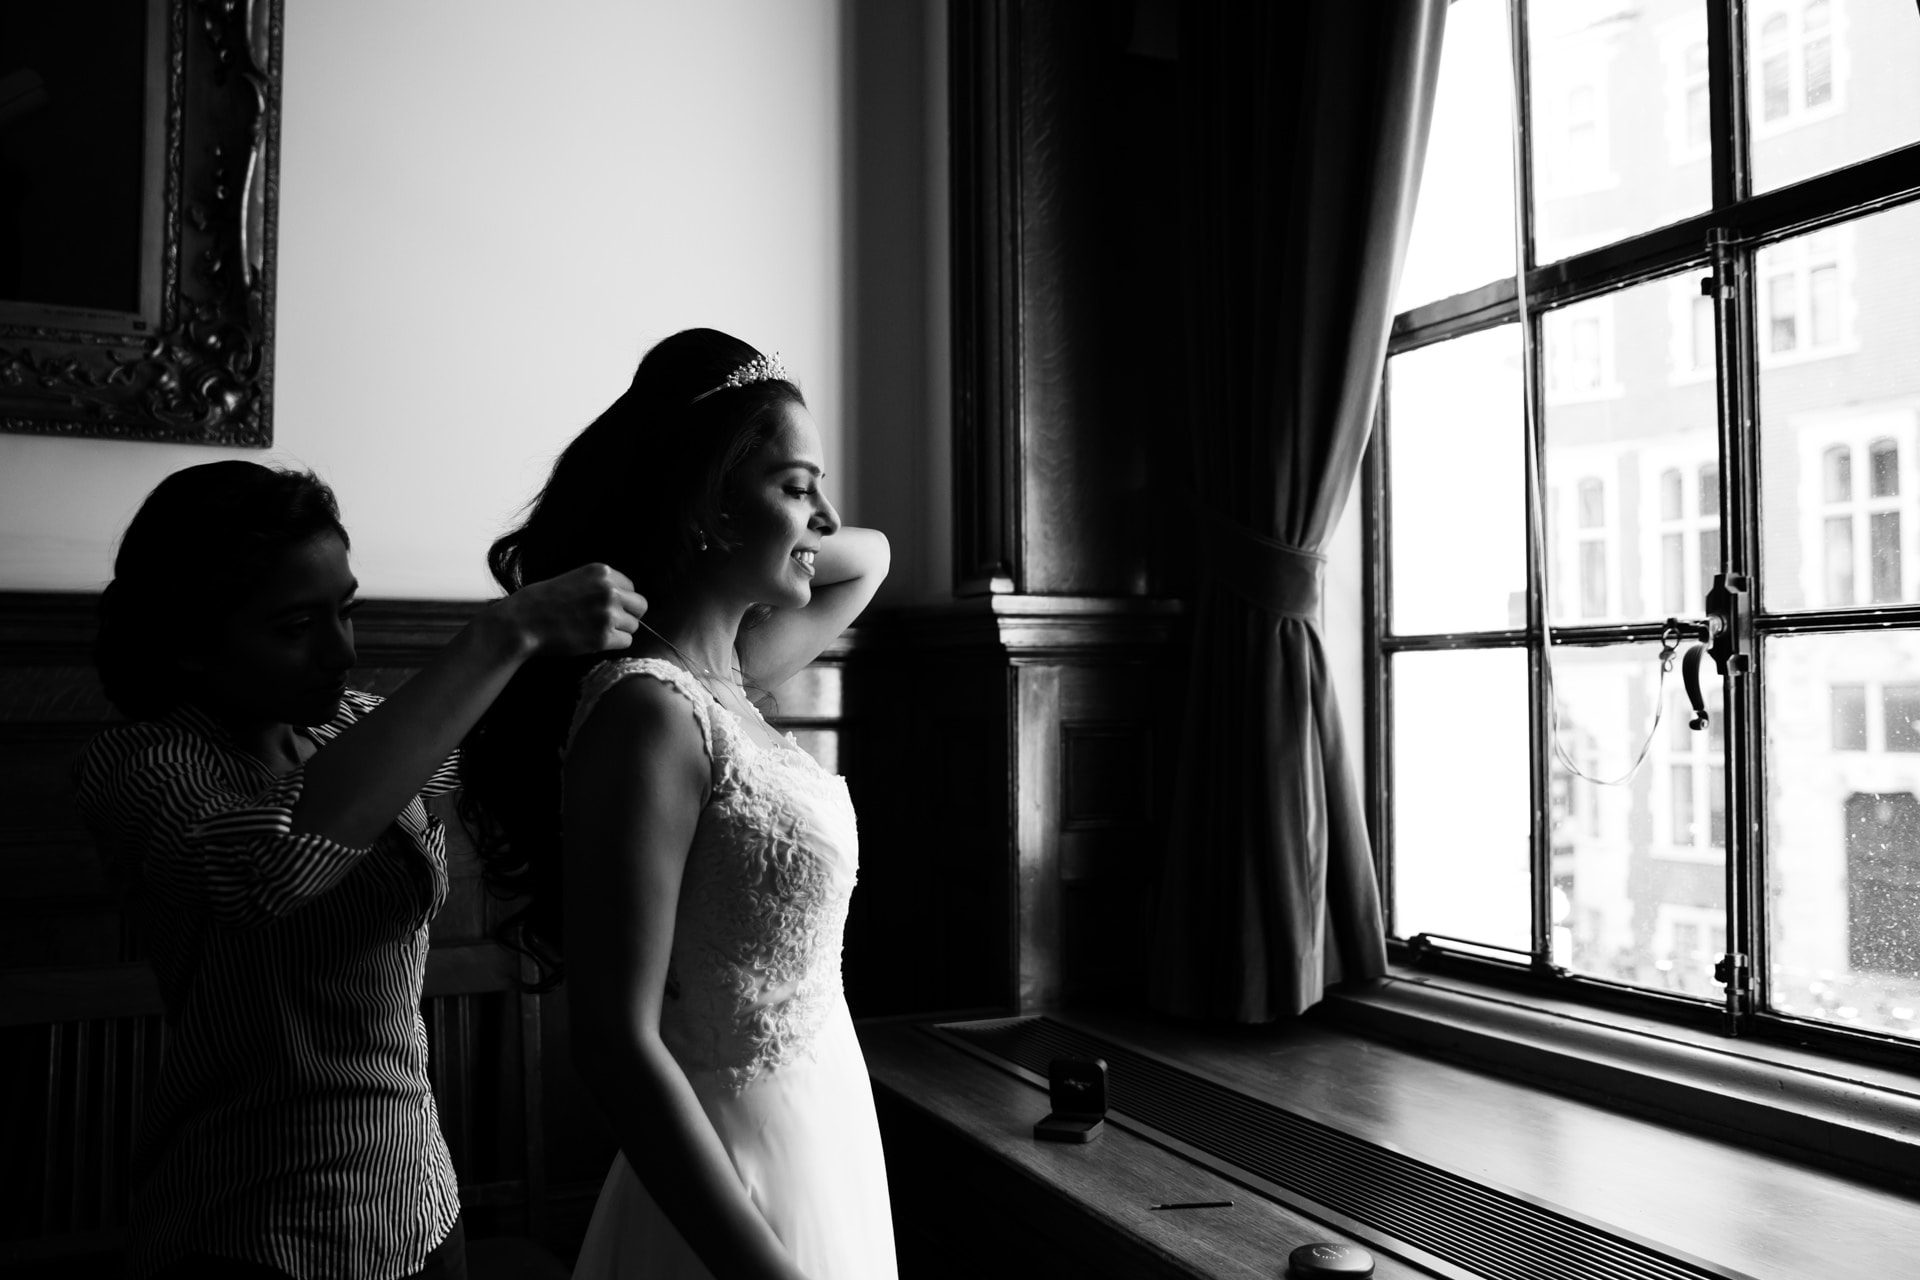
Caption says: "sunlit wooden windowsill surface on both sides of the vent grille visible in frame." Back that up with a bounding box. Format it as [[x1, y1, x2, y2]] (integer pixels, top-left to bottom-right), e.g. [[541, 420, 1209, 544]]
[[862, 1009, 1920, 1280]]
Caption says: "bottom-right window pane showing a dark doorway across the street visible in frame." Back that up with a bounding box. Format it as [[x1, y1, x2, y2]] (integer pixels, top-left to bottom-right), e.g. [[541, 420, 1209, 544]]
[[1761, 631, 1920, 1036]]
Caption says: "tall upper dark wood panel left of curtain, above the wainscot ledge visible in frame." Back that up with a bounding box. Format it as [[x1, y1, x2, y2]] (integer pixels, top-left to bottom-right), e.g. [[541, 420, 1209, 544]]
[[948, 0, 1188, 597]]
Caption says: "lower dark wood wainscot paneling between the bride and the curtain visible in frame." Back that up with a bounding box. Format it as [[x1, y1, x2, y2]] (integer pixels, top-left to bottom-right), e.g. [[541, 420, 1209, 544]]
[[847, 595, 1179, 1015]]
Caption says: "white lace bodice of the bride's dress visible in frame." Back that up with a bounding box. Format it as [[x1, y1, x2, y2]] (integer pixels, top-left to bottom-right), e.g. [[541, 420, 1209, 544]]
[[574, 658, 858, 1092]]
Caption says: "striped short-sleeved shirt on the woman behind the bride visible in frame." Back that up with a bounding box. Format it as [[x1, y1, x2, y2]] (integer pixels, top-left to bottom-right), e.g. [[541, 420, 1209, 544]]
[[75, 691, 461, 1280]]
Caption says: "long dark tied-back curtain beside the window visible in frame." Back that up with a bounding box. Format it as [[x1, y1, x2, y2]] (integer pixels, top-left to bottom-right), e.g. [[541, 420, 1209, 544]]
[[1148, 0, 1448, 1023]]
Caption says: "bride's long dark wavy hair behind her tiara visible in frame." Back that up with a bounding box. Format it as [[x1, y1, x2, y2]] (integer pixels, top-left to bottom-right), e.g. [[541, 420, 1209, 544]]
[[461, 328, 804, 990]]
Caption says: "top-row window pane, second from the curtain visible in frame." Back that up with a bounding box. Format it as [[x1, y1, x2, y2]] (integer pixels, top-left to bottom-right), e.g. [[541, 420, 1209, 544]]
[[1528, 0, 1713, 263]]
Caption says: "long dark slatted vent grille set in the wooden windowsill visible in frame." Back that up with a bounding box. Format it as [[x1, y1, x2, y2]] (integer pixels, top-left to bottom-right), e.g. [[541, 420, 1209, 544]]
[[927, 1017, 1751, 1280]]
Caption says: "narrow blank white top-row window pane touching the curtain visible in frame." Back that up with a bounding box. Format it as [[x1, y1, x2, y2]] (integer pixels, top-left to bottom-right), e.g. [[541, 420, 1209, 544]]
[[1394, 0, 1513, 311]]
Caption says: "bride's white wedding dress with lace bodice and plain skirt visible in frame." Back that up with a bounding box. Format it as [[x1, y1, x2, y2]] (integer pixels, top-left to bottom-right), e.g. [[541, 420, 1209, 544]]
[[574, 658, 897, 1280]]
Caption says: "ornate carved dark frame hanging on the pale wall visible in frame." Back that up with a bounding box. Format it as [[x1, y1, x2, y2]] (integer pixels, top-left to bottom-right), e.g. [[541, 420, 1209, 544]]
[[0, 0, 282, 447]]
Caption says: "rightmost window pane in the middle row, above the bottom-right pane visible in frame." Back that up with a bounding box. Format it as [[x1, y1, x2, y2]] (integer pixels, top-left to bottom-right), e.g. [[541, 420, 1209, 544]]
[[1759, 202, 1920, 612]]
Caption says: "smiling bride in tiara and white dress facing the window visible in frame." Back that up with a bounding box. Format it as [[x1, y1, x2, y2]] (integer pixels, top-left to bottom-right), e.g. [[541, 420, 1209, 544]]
[[465, 330, 895, 1280]]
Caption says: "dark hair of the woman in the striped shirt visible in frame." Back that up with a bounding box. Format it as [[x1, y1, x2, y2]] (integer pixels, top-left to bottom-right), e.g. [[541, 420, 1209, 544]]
[[94, 459, 348, 720]]
